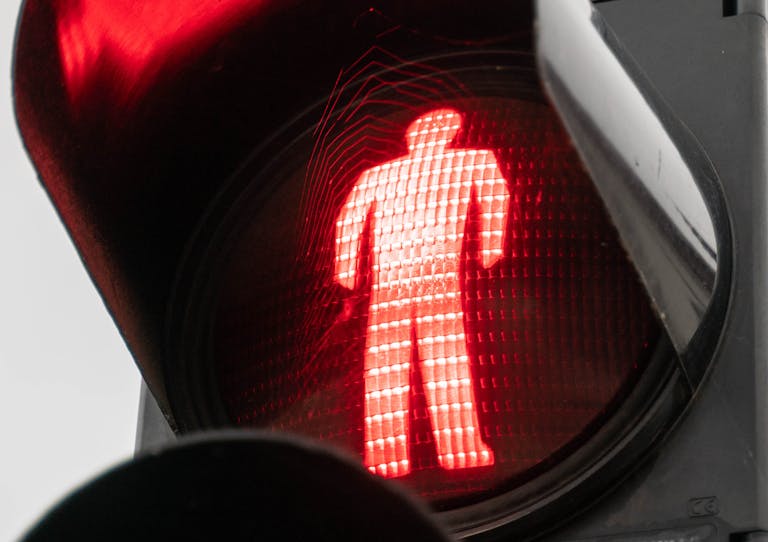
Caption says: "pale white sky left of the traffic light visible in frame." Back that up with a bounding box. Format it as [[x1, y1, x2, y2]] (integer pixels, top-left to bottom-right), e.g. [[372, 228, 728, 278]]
[[0, 0, 140, 541]]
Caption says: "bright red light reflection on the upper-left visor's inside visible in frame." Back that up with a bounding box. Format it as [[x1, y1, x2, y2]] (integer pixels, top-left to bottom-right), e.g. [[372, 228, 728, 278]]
[[57, 0, 262, 103]]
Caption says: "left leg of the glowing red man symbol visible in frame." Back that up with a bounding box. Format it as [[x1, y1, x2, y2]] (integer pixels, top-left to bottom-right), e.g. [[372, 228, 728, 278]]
[[365, 297, 412, 477]]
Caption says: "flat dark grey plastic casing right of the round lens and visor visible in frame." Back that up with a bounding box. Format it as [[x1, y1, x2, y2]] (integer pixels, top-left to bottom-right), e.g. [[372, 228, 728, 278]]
[[545, 0, 768, 542]]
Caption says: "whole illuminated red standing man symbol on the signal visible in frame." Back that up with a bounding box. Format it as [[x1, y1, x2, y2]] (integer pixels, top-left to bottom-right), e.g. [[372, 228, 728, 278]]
[[335, 109, 509, 476]]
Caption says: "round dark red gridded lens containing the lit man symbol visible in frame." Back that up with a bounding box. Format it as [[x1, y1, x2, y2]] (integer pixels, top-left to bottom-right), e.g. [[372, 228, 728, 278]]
[[210, 96, 660, 508]]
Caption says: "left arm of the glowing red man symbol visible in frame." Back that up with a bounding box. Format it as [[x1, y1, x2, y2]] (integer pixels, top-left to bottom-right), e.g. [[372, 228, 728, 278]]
[[333, 175, 373, 290]]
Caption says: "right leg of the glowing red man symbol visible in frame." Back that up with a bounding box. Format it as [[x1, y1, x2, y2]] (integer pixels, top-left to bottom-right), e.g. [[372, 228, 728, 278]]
[[416, 281, 493, 469]]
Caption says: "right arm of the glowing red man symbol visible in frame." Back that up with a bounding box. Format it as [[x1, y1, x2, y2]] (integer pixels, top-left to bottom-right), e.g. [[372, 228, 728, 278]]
[[475, 166, 510, 268]]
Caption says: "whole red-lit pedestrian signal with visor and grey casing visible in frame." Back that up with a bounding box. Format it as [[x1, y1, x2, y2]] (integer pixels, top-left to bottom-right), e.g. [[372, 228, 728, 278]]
[[14, 0, 768, 542]]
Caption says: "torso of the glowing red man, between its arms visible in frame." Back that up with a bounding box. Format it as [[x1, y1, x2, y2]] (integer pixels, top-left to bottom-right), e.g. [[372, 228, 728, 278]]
[[361, 150, 496, 297]]
